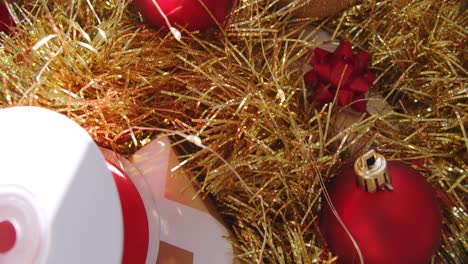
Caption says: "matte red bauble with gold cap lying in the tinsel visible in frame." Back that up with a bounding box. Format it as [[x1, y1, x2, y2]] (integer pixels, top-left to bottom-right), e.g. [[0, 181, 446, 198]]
[[320, 151, 442, 264]]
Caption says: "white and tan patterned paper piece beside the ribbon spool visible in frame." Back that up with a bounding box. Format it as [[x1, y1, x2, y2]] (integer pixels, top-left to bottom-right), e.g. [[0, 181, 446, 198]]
[[130, 137, 234, 264]]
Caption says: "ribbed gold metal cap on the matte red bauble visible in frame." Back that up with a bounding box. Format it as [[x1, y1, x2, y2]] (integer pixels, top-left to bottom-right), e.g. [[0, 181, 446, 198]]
[[354, 150, 393, 193]]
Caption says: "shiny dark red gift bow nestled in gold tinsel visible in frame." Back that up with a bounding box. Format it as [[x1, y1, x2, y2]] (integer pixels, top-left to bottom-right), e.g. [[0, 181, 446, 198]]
[[304, 41, 376, 112]]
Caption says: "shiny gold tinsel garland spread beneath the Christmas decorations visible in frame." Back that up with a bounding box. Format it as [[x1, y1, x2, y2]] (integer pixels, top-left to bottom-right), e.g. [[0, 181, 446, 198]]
[[0, 0, 468, 263]]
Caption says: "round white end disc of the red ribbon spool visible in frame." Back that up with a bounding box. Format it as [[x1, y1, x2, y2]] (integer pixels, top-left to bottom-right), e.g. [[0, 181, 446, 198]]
[[0, 107, 123, 264]]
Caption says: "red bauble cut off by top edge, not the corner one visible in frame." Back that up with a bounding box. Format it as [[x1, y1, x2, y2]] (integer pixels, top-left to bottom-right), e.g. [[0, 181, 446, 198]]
[[133, 0, 232, 30]]
